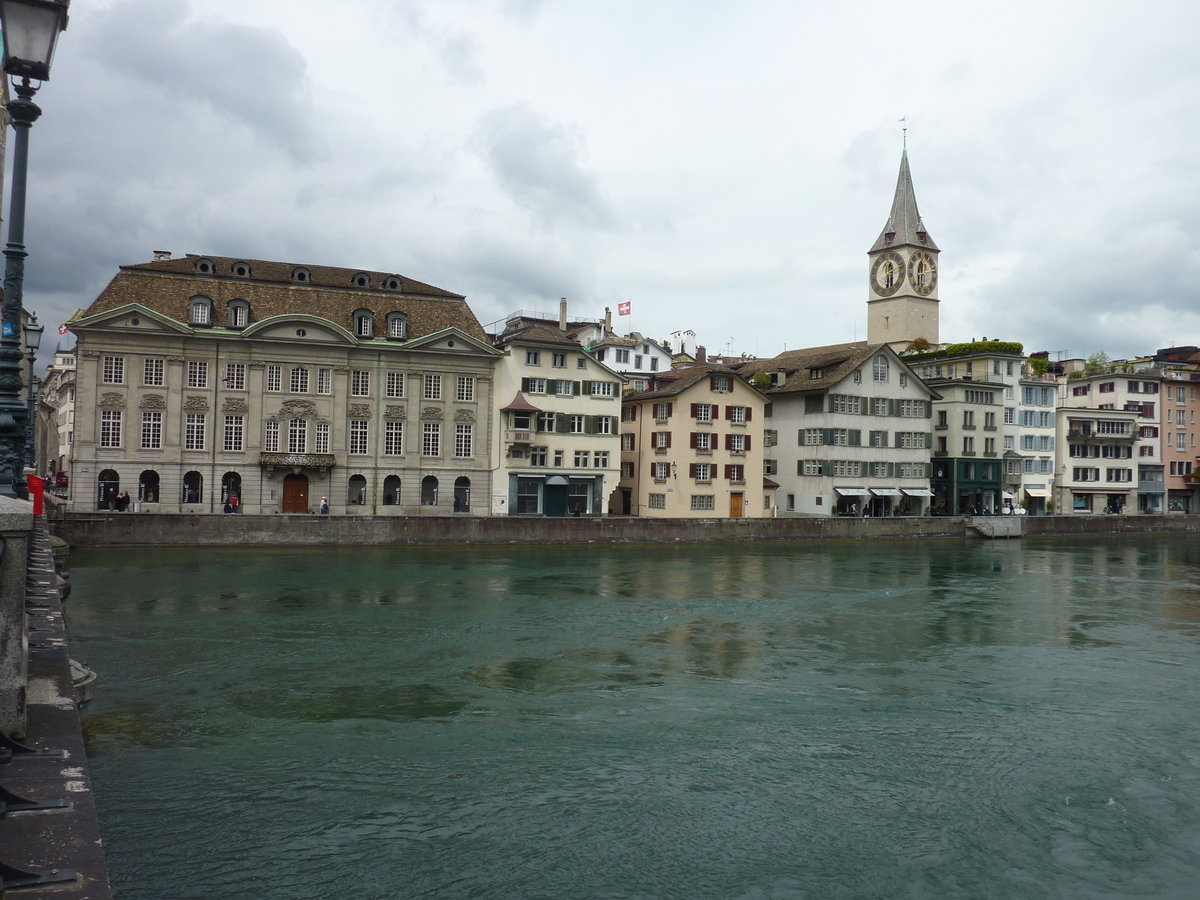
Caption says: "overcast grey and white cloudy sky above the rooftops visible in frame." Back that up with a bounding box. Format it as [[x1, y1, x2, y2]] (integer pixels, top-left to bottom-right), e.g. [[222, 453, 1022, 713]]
[[14, 0, 1200, 367]]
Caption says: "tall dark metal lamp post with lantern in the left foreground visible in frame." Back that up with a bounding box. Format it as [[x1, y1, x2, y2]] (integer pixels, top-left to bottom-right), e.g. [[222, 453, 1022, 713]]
[[0, 0, 71, 499]]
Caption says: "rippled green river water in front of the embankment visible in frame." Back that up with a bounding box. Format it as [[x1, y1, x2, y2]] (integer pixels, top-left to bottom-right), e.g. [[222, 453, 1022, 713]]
[[68, 535, 1200, 900]]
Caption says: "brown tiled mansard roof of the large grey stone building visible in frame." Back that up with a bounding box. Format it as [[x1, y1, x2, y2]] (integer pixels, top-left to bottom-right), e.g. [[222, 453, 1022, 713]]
[[84, 254, 487, 343]]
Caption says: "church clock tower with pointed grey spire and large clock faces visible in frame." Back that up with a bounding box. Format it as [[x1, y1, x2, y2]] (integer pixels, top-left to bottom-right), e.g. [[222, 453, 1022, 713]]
[[866, 148, 940, 352]]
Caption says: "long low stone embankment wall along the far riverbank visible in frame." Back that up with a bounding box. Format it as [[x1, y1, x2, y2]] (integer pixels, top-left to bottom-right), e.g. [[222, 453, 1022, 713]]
[[52, 512, 1200, 547]]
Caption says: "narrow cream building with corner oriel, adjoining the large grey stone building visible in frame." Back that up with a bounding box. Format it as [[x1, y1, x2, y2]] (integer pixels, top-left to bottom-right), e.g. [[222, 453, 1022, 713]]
[[492, 317, 624, 516]]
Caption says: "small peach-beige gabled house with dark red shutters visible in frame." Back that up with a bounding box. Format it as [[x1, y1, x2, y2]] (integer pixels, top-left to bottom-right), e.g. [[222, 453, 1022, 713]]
[[610, 366, 776, 518]]
